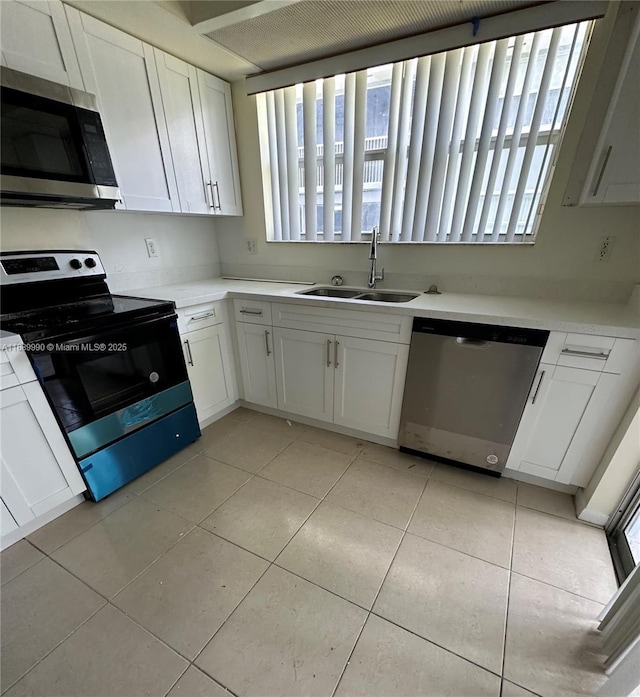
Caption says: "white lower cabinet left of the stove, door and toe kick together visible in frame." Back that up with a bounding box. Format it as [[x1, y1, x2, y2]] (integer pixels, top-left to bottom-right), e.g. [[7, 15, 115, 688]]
[[0, 382, 86, 537]]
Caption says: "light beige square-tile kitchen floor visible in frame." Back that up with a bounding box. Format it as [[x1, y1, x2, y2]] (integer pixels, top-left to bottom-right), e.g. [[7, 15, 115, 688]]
[[0, 409, 616, 697]]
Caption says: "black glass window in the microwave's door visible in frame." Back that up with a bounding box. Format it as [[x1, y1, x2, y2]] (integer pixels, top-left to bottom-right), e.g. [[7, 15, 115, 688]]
[[0, 88, 88, 182]]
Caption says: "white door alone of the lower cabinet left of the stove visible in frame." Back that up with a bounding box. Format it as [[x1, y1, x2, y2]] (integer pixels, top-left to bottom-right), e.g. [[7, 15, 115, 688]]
[[0, 385, 75, 525]]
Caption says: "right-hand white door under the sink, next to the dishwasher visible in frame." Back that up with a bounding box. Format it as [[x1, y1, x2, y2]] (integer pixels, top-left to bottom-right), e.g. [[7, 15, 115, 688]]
[[333, 336, 409, 438]]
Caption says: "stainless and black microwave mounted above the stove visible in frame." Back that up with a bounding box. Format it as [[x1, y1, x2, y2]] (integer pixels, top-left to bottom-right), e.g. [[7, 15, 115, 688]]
[[0, 68, 120, 209]]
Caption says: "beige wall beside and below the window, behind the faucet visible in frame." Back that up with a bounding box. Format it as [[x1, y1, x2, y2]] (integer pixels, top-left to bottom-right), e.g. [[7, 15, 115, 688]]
[[217, 3, 640, 302]]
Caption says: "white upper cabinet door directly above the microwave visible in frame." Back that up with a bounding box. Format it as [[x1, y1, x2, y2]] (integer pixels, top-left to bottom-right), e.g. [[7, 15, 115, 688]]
[[1, 0, 84, 90]]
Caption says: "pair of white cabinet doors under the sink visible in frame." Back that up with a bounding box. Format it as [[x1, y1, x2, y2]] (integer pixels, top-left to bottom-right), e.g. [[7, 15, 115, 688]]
[[274, 328, 409, 438]]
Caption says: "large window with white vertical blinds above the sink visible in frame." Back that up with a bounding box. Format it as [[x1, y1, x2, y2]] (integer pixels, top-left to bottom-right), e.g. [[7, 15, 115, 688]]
[[258, 22, 591, 243]]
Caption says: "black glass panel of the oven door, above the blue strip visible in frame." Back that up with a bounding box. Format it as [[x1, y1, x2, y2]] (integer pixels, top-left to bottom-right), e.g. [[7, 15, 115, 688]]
[[31, 319, 187, 432]]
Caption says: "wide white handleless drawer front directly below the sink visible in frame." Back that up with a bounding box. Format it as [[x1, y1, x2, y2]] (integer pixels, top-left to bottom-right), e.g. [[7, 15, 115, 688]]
[[273, 304, 412, 344]]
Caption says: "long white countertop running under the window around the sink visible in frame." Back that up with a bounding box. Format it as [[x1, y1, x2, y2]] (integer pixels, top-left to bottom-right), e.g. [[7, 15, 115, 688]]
[[126, 278, 640, 339]]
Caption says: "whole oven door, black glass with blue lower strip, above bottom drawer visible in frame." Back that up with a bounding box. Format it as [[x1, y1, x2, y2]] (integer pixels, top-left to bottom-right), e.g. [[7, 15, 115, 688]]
[[29, 315, 193, 459]]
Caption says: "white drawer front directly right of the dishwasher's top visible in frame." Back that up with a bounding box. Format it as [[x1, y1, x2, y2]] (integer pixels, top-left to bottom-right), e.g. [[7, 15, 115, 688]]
[[542, 332, 637, 374]]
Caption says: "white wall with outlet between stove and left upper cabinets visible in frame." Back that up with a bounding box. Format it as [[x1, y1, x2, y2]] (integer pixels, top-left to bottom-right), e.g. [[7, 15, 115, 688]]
[[0, 208, 220, 291]]
